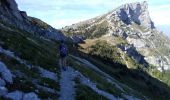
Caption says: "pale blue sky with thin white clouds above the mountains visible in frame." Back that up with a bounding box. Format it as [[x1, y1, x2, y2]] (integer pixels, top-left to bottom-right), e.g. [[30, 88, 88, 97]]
[[16, 0, 170, 36]]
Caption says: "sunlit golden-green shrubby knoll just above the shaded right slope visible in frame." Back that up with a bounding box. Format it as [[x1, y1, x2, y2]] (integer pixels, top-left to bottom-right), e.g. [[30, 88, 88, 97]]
[[80, 38, 137, 68]]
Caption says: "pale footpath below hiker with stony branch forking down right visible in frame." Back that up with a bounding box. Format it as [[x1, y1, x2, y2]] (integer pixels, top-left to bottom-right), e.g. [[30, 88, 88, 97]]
[[59, 67, 121, 100]]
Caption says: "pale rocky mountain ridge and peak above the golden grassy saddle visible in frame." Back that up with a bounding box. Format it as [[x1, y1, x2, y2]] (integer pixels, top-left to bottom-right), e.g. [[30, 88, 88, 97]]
[[62, 1, 170, 71]]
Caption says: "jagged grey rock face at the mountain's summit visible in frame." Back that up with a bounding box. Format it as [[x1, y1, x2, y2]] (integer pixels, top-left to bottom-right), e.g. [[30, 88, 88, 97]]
[[116, 1, 154, 28]]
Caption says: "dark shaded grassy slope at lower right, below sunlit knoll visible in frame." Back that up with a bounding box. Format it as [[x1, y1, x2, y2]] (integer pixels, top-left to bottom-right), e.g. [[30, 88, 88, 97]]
[[77, 53, 170, 100]]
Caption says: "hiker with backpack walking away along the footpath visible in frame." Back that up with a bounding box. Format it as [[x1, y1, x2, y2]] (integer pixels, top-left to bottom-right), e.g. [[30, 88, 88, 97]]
[[59, 40, 68, 71]]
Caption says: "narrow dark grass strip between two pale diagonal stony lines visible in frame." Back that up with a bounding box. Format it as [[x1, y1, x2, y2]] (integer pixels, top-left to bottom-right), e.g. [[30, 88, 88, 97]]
[[70, 58, 121, 97]]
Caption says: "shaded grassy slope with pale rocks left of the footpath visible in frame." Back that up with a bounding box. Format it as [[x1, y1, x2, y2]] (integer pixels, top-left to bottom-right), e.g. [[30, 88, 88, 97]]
[[0, 19, 59, 100]]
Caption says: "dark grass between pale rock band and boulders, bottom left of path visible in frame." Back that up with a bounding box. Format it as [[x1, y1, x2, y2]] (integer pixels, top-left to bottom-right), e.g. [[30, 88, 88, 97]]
[[0, 54, 59, 99]]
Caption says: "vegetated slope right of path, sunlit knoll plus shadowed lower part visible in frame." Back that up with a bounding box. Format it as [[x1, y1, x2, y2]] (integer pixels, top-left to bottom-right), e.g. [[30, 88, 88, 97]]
[[71, 41, 170, 100]]
